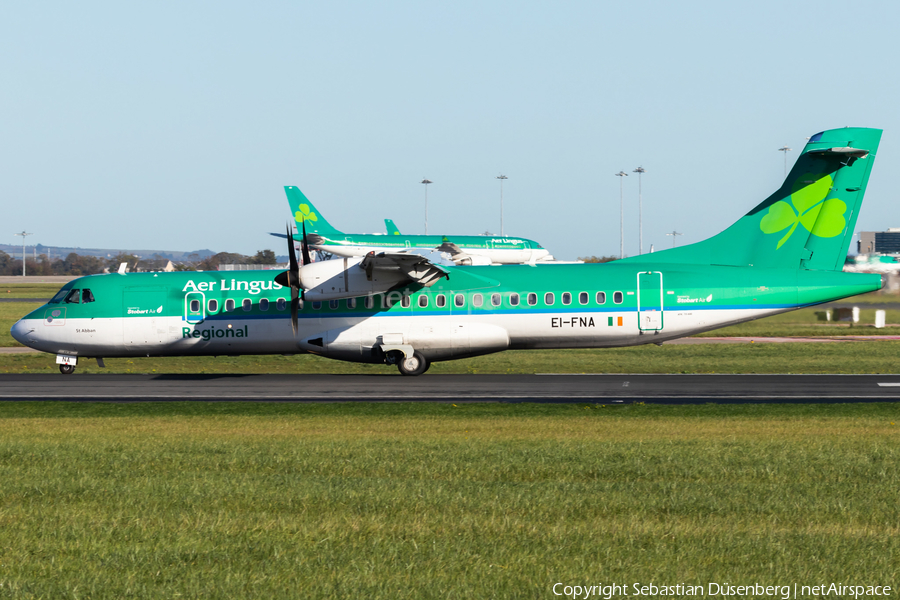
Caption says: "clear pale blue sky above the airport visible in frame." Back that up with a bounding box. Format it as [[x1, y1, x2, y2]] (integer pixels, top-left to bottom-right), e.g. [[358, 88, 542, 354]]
[[0, 0, 900, 260]]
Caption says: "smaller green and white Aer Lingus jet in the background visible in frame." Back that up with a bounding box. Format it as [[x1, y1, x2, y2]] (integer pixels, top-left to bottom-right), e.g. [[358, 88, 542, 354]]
[[272, 185, 553, 265]]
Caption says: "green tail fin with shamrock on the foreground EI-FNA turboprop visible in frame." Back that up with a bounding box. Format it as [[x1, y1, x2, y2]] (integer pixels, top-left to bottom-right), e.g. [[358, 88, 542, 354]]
[[625, 127, 881, 271]]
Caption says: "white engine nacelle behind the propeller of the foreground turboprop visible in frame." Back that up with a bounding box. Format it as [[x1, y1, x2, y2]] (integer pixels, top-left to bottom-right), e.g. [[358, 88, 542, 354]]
[[299, 256, 409, 301]]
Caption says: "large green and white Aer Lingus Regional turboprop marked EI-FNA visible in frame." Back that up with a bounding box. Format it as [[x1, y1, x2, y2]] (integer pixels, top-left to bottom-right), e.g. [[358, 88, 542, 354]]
[[11, 128, 882, 375]]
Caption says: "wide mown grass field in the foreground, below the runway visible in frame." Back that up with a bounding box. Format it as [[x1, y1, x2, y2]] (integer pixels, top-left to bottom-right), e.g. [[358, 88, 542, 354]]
[[0, 403, 900, 599]]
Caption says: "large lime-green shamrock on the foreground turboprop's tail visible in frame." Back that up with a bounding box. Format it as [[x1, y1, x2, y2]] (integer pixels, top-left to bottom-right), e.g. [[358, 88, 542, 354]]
[[759, 173, 847, 250]]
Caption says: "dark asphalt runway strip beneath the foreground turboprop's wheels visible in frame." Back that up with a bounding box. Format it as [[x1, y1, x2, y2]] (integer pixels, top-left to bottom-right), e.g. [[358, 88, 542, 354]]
[[0, 374, 900, 404]]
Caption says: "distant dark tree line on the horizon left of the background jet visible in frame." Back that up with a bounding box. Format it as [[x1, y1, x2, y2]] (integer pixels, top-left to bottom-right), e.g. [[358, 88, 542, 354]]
[[0, 250, 277, 275]]
